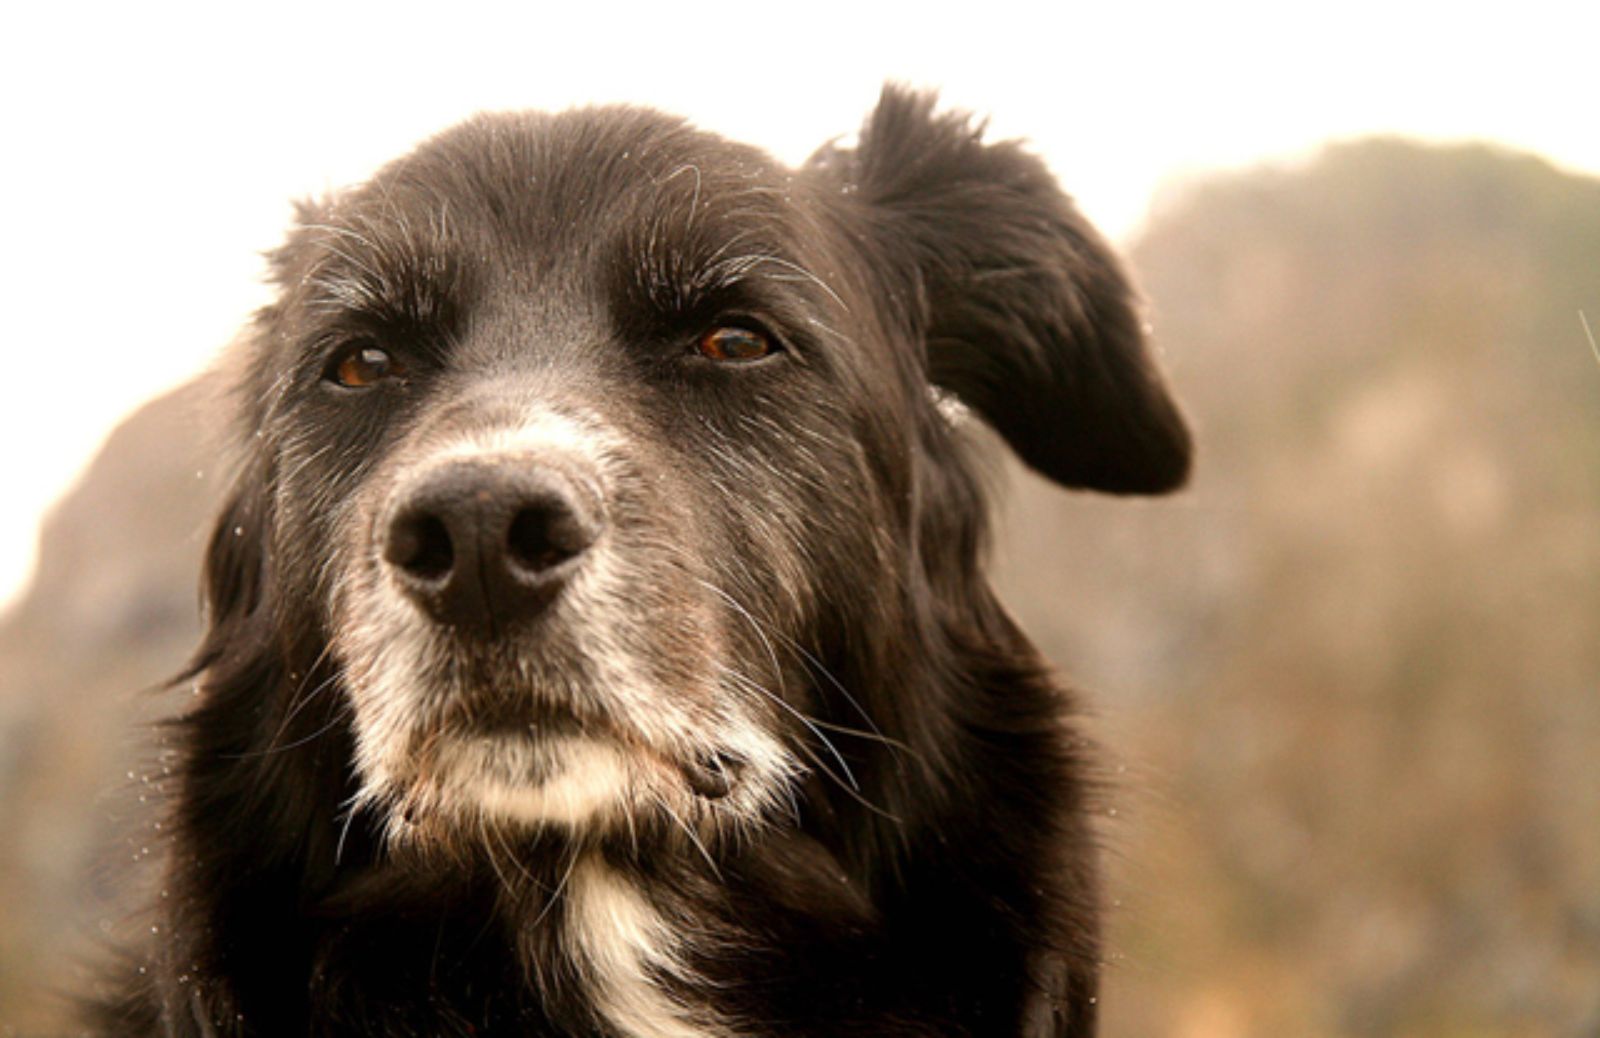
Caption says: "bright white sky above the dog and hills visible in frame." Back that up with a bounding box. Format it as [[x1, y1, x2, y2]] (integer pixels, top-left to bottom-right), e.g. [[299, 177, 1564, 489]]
[[0, 0, 1600, 601]]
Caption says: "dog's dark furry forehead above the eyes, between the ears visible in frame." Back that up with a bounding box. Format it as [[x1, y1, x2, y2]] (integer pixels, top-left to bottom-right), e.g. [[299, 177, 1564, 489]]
[[278, 107, 822, 356]]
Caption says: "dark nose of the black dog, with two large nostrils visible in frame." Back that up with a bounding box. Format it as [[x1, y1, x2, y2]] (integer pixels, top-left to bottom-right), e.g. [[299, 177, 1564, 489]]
[[382, 461, 605, 633]]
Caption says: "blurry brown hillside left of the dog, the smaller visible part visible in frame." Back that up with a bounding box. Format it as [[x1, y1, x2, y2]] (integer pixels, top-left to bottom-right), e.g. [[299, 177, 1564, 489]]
[[0, 384, 218, 1035]]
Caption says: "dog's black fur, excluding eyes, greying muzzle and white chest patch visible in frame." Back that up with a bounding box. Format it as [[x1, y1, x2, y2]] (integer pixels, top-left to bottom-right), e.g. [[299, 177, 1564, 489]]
[[98, 88, 1189, 1038]]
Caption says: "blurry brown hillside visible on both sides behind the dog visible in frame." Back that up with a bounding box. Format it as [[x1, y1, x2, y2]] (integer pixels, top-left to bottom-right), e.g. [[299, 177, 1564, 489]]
[[0, 141, 1600, 1038]]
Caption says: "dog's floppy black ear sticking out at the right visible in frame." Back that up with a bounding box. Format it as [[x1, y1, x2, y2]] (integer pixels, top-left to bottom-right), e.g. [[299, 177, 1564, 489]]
[[813, 86, 1190, 494]]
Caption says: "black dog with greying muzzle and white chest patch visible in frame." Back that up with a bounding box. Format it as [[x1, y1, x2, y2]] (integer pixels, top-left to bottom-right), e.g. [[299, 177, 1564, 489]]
[[96, 86, 1190, 1038]]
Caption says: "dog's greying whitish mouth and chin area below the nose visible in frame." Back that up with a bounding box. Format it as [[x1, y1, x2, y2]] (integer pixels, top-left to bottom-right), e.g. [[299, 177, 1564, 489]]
[[338, 492, 798, 841]]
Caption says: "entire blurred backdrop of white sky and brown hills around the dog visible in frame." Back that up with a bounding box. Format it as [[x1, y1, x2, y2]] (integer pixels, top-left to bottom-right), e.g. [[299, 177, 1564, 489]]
[[0, 0, 1600, 1038]]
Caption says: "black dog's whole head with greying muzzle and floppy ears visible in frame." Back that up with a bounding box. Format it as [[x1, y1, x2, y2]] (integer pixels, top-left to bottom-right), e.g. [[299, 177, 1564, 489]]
[[205, 90, 1189, 850]]
